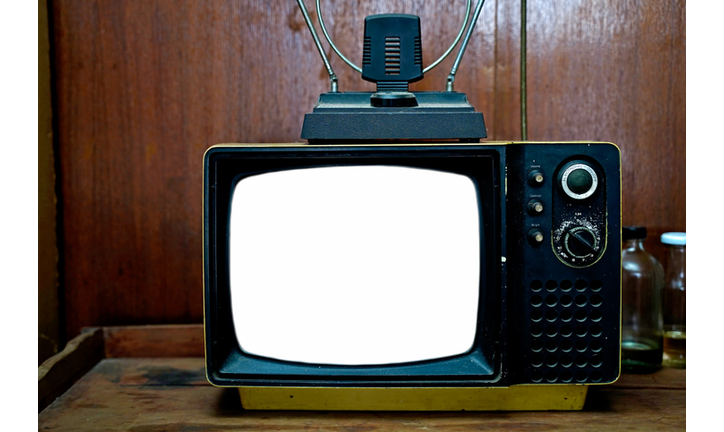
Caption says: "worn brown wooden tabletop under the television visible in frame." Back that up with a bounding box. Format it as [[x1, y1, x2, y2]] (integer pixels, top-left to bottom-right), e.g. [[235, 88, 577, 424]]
[[38, 326, 686, 432]]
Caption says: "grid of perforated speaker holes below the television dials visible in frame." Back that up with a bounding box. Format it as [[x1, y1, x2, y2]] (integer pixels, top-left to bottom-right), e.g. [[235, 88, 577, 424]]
[[526, 279, 605, 383]]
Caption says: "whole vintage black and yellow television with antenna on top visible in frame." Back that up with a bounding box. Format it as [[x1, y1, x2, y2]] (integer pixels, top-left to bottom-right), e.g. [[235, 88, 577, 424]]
[[203, 1, 621, 410]]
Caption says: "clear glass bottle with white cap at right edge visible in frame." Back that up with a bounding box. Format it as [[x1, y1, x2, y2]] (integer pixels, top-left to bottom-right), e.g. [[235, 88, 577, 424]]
[[661, 232, 686, 369]]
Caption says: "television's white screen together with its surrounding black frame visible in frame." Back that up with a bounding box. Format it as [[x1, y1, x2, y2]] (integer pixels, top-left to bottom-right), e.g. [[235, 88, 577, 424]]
[[204, 145, 504, 386]]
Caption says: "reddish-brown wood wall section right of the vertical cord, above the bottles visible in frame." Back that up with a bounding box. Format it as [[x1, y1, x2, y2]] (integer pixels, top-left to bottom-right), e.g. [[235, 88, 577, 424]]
[[528, 0, 686, 259]]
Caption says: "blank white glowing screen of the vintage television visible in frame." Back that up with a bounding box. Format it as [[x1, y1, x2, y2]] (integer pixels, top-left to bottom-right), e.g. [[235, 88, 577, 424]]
[[229, 166, 480, 365]]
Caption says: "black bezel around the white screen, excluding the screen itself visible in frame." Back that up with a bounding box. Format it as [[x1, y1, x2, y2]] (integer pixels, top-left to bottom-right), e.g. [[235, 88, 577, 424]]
[[204, 145, 505, 387]]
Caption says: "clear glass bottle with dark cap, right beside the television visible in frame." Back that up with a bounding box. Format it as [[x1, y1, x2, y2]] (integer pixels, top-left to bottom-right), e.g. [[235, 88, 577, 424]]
[[621, 227, 664, 373]]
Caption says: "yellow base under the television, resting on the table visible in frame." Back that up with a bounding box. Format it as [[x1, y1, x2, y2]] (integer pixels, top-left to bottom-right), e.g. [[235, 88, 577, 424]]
[[239, 384, 588, 411]]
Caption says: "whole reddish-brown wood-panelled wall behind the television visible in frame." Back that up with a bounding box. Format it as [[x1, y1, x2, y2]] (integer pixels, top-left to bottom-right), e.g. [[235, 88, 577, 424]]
[[51, 0, 686, 337]]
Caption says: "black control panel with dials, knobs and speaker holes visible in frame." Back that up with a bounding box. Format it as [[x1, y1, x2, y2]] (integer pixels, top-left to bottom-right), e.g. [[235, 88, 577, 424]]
[[506, 143, 621, 384]]
